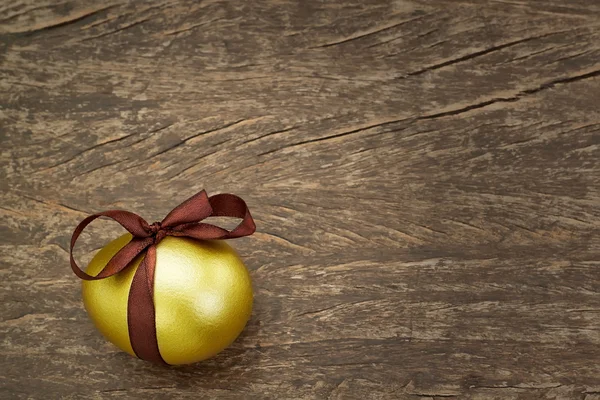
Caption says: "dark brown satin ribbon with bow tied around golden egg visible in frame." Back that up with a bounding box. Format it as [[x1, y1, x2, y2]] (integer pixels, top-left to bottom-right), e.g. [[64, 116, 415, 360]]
[[70, 190, 256, 364]]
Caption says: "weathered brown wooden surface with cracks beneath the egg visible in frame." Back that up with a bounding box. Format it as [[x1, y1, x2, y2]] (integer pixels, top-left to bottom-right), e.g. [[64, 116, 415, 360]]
[[0, 0, 600, 400]]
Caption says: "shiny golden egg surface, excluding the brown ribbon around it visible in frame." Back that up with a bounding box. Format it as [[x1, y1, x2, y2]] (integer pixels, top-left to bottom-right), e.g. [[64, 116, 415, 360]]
[[82, 234, 252, 365]]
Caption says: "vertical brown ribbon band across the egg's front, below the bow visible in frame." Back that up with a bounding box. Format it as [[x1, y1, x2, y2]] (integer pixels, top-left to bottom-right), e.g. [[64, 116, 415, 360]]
[[127, 245, 167, 364]]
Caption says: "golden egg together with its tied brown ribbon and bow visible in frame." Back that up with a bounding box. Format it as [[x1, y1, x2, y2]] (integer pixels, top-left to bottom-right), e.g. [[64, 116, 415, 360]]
[[70, 190, 256, 364]]
